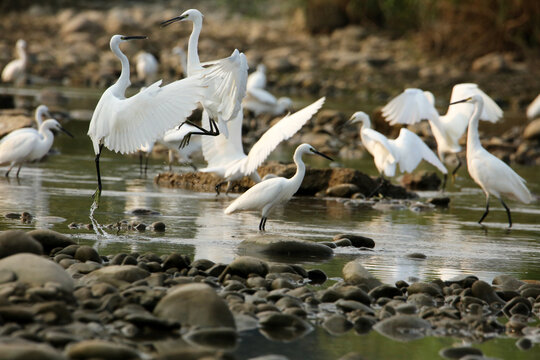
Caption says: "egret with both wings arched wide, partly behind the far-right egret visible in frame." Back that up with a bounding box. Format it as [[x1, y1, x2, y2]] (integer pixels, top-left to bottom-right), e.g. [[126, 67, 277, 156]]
[[382, 83, 503, 180]]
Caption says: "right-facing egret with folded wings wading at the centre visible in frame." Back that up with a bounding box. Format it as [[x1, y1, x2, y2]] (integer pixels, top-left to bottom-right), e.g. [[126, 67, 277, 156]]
[[225, 144, 332, 231]]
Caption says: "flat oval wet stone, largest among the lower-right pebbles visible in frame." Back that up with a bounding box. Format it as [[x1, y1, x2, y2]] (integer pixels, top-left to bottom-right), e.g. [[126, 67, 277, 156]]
[[373, 315, 431, 341]]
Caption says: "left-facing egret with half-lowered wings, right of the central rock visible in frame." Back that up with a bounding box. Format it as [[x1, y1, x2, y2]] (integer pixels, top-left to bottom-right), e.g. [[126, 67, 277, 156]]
[[349, 111, 448, 192]]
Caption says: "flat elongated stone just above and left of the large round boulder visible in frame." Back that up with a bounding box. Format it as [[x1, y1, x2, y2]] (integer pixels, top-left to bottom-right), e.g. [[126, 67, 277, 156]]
[[79, 265, 150, 287]]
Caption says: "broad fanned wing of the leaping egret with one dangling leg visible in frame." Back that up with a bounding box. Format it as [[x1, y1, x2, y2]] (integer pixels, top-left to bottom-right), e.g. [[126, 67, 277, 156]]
[[99, 76, 204, 153]]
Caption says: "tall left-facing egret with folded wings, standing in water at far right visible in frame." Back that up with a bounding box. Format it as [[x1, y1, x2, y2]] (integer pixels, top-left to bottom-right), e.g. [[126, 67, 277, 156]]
[[450, 94, 533, 227]]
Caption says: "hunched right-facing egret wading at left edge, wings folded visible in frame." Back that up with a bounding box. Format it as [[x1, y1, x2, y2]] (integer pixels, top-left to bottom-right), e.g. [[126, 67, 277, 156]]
[[0, 119, 73, 177]]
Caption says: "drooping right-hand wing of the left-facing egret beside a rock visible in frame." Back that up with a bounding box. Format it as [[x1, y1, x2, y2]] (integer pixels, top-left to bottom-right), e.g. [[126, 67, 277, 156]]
[[389, 128, 448, 174]]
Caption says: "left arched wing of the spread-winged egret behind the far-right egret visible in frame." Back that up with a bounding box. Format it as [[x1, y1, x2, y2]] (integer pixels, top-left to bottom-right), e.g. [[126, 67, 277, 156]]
[[382, 88, 439, 125]]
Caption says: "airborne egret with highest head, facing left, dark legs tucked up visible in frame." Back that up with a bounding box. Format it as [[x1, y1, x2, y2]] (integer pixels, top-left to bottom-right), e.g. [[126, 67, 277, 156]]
[[161, 9, 248, 145]]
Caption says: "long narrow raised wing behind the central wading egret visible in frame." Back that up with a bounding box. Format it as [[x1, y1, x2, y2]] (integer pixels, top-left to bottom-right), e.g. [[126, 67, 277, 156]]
[[237, 97, 325, 175]]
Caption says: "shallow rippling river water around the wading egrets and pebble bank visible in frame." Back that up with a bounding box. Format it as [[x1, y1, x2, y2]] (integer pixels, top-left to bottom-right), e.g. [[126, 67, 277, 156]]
[[0, 113, 540, 359]]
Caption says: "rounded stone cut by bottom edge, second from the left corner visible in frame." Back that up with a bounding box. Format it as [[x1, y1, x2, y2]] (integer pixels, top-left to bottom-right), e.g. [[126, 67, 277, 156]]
[[65, 340, 141, 360]]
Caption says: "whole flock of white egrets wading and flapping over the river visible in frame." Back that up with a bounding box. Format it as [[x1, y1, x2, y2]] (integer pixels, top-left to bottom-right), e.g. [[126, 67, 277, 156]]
[[0, 9, 540, 231]]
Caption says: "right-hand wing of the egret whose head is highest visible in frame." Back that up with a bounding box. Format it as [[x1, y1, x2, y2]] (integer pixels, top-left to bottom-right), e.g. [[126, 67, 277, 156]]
[[202, 49, 248, 121]]
